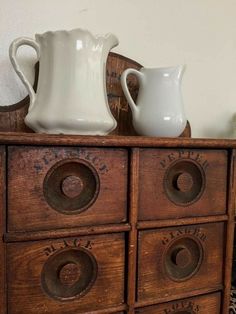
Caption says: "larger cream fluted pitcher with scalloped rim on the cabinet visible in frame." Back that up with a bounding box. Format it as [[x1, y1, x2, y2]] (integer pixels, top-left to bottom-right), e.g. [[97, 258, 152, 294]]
[[9, 29, 119, 135]]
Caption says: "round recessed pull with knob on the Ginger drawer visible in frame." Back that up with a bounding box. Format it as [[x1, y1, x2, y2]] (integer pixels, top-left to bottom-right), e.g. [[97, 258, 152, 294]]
[[163, 237, 203, 281]]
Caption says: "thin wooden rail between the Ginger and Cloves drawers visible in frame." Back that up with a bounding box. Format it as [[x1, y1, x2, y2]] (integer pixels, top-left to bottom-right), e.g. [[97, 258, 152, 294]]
[[135, 285, 223, 314]]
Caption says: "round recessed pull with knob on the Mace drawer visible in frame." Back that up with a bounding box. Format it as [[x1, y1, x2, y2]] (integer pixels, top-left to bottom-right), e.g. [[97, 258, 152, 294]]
[[41, 248, 97, 300]]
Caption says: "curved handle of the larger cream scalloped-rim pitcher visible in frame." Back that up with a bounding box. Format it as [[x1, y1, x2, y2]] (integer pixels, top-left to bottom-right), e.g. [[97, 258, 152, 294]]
[[9, 37, 40, 111]]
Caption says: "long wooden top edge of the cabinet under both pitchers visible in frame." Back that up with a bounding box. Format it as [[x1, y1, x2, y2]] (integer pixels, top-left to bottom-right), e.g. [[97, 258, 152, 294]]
[[0, 132, 236, 148]]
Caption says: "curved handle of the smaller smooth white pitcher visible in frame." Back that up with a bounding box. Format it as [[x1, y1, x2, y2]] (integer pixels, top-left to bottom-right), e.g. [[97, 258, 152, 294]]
[[121, 68, 144, 115]]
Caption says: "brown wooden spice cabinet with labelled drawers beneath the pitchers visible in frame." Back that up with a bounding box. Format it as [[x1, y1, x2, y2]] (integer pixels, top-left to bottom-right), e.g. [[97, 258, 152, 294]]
[[0, 133, 236, 314]]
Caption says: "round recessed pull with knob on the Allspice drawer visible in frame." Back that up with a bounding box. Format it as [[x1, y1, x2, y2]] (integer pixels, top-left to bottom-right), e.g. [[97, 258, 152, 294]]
[[44, 159, 99, 214]]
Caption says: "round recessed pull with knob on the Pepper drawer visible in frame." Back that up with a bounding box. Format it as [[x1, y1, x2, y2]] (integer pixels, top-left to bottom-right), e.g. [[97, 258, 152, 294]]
[[164, 160, 205, 206]]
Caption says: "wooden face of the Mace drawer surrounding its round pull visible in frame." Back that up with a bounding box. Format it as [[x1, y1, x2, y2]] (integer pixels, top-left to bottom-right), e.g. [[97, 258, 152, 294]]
[[7, 234, 125, 314]]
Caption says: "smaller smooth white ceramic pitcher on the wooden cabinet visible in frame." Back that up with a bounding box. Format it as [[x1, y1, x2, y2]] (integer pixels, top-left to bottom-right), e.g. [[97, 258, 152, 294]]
[[121, 66, 187, 137]]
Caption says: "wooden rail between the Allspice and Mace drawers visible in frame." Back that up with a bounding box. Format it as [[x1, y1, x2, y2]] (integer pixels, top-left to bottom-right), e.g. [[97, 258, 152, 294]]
[[4, 223, 131, 243]]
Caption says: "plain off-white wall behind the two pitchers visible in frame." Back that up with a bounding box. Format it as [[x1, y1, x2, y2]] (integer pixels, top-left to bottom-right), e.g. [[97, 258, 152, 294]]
[[0, 0, 236, 138]]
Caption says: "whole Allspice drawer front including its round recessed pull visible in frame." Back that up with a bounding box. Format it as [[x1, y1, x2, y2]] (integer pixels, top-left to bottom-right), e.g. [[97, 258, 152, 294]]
[[8, 147, 127, 231]]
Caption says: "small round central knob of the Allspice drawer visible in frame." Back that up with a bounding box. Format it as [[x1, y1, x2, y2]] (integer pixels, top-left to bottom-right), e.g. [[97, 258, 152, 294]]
[[61, 176, 83, 198]]
